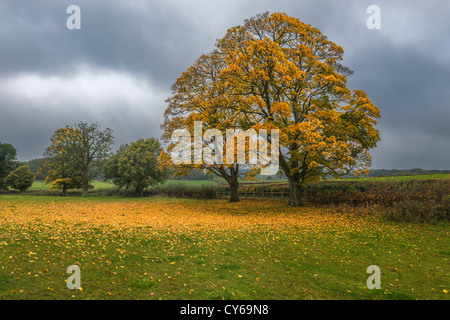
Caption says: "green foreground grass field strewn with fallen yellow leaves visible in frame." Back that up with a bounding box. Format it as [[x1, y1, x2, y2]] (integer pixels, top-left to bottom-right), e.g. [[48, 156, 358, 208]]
[[0, 195, 450, 299]]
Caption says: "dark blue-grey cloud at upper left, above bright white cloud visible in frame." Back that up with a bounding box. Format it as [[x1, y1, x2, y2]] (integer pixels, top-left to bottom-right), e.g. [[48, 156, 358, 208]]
[[0, 1, 214, 86]]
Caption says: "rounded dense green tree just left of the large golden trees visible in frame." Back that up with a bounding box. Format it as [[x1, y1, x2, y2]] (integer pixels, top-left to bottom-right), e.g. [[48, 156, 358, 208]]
[[103, 138, 169, 197]]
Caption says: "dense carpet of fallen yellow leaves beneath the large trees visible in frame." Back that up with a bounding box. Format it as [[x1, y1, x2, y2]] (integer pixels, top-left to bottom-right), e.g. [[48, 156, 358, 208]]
[[0, 199, 367, 235]]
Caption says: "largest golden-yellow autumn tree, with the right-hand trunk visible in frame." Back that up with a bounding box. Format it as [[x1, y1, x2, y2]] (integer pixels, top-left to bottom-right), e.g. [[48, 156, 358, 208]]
[[162, 13, 380, 206]]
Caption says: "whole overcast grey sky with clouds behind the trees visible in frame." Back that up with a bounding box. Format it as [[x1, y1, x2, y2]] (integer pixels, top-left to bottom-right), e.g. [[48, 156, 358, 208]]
[[0, 0, 450, 169]]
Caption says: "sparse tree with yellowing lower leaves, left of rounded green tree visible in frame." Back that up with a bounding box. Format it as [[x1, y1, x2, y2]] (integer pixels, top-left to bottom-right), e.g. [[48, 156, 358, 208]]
[[45, 122, 114, 196]]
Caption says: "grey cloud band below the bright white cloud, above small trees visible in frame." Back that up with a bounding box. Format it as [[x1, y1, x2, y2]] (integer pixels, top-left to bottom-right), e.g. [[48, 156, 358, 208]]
[[0, 92, 161, 160]]
